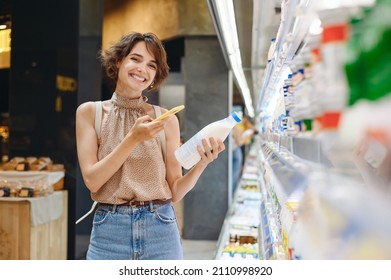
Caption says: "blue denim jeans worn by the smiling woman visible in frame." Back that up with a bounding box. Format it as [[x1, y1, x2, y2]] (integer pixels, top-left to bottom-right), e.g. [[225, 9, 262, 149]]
[[87, 200, 183, 260]]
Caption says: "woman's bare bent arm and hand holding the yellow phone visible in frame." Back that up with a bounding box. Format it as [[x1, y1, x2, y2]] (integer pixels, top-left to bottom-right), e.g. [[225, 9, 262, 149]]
[[76, 102, 165, 192]]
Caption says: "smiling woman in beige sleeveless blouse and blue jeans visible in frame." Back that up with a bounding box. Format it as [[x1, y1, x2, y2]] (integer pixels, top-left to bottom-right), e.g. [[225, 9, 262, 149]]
[[76, 32, 225, 259]]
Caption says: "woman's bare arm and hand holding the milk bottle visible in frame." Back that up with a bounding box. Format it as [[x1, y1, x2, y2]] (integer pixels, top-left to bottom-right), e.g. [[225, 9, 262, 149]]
[[165, 116, 225, 202]]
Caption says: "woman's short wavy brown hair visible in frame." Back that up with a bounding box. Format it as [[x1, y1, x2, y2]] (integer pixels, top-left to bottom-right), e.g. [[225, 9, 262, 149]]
[[100, 32, 169, 91]]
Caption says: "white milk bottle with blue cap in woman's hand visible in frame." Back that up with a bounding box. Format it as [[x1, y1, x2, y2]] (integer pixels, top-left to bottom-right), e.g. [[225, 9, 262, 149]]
[[175, 112, 241, 169]]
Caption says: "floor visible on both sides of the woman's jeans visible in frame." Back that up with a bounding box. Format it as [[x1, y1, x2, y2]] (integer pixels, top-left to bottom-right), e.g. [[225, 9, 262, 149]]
[[76, 235, 217, 260]]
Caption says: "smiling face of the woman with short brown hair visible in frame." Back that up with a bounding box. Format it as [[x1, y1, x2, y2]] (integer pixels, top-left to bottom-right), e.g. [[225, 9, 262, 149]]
[[117, 41, 157, 94]]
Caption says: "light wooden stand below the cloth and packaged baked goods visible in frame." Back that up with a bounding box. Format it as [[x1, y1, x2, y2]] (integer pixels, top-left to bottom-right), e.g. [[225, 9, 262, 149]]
[[0, 191, 68, 260]]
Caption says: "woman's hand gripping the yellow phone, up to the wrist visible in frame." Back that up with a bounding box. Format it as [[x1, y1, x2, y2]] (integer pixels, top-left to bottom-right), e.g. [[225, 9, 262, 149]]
[[127, 115, 168, 142]]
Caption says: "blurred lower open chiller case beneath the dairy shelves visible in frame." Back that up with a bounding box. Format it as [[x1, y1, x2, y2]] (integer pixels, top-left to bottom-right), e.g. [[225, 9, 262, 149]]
[[216, 139, 391, 260]]
